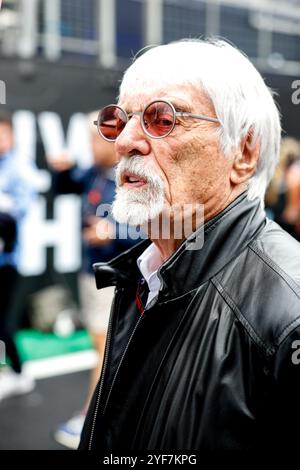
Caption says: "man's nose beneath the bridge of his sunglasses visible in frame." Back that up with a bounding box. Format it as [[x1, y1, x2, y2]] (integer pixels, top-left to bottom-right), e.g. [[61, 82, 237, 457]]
[[115, 115, 151, 159]]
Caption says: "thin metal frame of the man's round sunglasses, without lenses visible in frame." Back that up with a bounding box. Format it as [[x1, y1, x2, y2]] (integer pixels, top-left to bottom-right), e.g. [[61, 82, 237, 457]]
[[93, 100, 220, 142]]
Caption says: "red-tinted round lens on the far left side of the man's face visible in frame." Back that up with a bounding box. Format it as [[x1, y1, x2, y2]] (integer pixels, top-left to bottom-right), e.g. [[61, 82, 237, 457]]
[[98, 106, 127, 141]]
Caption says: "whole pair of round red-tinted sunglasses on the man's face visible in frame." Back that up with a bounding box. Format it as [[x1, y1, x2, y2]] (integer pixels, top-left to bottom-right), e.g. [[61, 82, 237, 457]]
[[94, 100, 219, 142]]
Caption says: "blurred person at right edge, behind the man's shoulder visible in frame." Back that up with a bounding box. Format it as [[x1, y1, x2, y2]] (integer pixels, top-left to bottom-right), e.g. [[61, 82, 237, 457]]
[[265, 137, 300, 241]]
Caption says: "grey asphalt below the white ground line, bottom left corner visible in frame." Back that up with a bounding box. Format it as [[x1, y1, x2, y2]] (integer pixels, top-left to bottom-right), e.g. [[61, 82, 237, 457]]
[[0, 370, 90, 450]]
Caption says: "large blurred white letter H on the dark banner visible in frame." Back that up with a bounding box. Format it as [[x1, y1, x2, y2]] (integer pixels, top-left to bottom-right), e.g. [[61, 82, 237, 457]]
[[19, 195, 81, 276]]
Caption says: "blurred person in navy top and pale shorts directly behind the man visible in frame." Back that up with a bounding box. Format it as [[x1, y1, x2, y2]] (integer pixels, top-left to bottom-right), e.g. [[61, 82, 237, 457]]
[[47, 113, 135, 448]]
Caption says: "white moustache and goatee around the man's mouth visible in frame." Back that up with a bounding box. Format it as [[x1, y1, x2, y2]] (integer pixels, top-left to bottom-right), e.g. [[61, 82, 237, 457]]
[[112, 155, 165, 226]]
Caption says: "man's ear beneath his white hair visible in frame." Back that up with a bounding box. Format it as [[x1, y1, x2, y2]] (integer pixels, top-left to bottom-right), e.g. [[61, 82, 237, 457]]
[[230, 129, 260, 184]]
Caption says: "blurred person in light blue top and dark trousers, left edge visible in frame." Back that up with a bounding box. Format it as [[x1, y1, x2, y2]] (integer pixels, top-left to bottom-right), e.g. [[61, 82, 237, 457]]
[[0, 112, 35, 400]]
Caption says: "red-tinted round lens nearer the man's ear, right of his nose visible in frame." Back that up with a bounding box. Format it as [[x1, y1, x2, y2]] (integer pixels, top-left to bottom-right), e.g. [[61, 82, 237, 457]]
[[143, 101, 175, 137]]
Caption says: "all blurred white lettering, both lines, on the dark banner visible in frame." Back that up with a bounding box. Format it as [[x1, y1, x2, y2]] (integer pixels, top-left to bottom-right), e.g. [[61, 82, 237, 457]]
[[13, 110, 92, 276]]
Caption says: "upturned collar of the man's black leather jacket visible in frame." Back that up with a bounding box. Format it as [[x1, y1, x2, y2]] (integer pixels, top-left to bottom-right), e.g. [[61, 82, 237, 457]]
[[94, 192, 266, 300]]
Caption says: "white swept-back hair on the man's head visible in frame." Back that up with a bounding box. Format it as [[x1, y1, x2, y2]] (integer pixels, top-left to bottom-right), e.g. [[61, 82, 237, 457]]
[[120, 39, 281, 205]]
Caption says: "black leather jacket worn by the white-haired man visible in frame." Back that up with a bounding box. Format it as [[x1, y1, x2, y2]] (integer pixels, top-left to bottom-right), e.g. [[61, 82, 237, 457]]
[[79, 193, 300, 452]]
